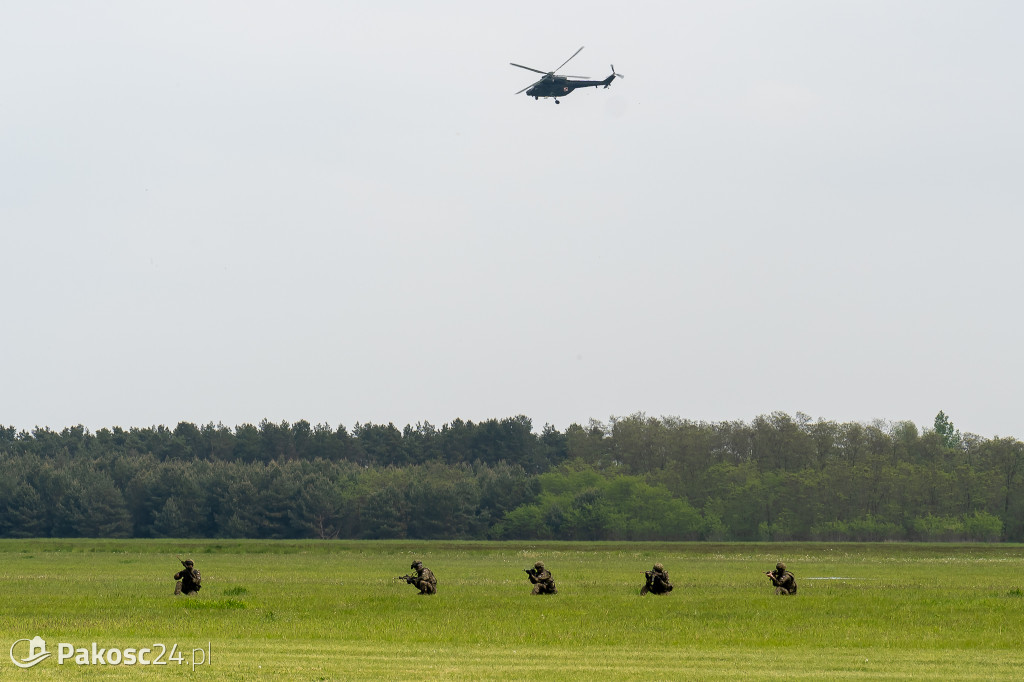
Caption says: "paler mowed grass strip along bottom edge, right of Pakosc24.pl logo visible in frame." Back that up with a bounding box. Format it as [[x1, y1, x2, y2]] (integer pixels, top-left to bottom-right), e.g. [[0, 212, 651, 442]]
[[197, 644, 1024, 680]]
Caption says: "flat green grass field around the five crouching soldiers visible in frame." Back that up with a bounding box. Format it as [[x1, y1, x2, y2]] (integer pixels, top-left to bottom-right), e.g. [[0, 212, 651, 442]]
[[0, 540, 1024, 680]]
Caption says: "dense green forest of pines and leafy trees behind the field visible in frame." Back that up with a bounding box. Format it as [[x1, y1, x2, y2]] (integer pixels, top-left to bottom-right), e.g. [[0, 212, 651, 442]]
[[0, 412, 1024, 542]]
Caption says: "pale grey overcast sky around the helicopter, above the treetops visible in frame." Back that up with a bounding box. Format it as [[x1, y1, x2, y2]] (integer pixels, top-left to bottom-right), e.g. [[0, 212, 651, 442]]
[[0, 0, 1024, 437]]
